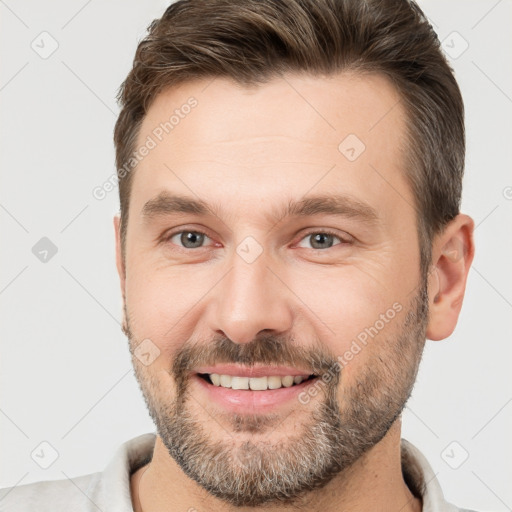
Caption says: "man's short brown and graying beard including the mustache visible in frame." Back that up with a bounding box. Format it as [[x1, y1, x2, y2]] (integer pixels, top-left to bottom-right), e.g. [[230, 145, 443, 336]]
[[123, 280, 428, 507]]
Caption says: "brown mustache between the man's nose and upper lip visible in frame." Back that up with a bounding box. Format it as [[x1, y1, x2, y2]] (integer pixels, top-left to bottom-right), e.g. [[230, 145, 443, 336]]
[[172, 334, 337, 378]]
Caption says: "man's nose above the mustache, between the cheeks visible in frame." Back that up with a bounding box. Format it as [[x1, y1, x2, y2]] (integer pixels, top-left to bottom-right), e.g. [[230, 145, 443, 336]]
[[209, 249, 293, 343]]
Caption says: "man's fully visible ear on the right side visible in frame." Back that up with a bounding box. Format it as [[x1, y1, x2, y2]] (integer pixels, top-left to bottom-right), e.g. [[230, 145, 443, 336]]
[[426, 214, 475, 341]]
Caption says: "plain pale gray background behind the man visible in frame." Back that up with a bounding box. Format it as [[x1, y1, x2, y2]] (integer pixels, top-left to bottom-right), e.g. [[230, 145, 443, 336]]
[[0, 0, 512, 511]]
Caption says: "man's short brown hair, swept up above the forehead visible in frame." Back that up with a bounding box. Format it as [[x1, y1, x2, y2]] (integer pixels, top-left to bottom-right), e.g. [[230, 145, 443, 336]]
[[114, 0, 465, 275]]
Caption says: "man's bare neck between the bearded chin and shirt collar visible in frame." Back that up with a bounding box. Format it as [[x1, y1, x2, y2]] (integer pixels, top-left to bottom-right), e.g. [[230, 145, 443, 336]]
[[131, 420, 422, 512]]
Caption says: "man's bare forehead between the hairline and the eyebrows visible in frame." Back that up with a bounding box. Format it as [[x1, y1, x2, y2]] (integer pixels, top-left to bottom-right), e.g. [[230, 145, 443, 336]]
[[130, 74, 413, 222]]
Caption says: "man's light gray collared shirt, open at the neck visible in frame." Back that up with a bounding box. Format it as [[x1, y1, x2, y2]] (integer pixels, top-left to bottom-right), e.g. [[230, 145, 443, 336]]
[[0, 434, 478, 512]]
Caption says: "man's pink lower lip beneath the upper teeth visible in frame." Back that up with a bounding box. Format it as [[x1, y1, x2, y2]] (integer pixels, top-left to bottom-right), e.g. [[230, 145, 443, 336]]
[[192, 375, 318, 414]]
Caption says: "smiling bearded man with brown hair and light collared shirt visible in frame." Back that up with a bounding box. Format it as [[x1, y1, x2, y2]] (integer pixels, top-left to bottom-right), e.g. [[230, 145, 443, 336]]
[[4, 0, 474, 512]]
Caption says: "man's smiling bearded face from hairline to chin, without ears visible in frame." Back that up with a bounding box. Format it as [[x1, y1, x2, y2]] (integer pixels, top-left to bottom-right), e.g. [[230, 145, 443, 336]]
[[118, 74, 428, 505]]
